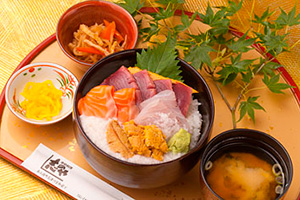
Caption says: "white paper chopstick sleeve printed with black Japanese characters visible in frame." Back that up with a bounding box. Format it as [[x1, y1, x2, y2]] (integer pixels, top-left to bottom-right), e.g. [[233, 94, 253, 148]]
[[22, 144, 132, 200]]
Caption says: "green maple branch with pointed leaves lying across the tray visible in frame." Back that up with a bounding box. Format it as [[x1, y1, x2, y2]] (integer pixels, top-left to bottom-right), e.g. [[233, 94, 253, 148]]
[[118, 0, 300, 128]]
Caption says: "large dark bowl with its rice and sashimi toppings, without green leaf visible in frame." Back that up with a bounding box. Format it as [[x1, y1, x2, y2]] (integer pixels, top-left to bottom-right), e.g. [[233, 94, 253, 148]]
[[74, 49, 214, 188]]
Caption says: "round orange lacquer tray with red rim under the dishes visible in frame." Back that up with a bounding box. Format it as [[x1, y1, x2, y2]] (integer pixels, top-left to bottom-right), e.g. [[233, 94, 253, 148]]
[[0, 13, 300, 200]]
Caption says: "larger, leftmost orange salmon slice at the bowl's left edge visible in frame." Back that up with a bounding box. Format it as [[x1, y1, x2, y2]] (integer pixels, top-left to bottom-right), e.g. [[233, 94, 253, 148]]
[[78, 85, 117, 119]]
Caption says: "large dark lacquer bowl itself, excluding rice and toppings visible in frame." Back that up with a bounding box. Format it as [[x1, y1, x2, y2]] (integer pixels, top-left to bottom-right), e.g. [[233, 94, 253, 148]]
[[73, 49, 214, 188]]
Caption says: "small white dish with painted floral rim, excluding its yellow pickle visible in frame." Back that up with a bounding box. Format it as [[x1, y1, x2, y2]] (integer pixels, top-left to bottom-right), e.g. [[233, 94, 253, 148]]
[[5, 62, 78, 125]]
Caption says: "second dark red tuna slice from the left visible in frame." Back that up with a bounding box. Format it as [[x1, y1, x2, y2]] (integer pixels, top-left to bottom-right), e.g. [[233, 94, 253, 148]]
[[133, 70, 156, 101]]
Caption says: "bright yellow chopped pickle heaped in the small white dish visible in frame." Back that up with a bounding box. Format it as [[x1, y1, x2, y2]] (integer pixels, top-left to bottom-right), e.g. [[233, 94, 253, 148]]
[[21, 80, 62, 121]]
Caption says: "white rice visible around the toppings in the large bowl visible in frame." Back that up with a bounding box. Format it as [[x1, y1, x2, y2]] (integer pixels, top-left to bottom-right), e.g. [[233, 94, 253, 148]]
[[80, 100, 202, 164]]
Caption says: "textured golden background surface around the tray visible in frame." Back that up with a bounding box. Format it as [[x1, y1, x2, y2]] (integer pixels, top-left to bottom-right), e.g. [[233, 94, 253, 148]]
[[0, 0, 300, 200]]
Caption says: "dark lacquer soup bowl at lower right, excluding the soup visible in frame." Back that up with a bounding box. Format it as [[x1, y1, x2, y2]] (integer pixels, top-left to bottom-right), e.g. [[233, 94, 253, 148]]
[[200, 129, 293, 200]]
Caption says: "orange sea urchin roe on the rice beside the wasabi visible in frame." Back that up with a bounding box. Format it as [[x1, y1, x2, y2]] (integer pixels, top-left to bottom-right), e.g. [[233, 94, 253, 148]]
[[106, 120, 168, 161]]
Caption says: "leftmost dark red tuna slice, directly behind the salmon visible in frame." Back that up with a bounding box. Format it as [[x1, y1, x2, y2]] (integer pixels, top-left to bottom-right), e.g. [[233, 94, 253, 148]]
[[101, 66, 142, 105]]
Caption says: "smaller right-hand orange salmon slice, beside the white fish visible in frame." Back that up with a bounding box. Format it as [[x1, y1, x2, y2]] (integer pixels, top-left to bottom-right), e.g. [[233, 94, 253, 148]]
[[113, 88, 139, 122]]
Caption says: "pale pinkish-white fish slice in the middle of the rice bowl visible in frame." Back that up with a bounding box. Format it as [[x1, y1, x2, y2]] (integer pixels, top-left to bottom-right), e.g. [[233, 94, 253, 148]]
[[134, 90, 190, 140]]
